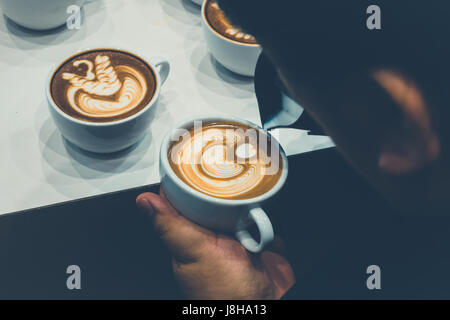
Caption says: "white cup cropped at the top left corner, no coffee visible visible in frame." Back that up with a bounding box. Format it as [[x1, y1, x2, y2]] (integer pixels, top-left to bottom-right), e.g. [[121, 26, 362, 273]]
[[0, 0, 92, 30]]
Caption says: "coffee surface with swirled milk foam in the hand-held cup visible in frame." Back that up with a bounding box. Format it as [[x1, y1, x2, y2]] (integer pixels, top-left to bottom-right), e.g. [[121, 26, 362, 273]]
[[167, 121, 283, 200]]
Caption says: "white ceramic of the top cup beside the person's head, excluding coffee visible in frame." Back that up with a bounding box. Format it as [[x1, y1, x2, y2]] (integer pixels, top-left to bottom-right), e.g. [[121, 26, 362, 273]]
[[202, 0, 262, 77]]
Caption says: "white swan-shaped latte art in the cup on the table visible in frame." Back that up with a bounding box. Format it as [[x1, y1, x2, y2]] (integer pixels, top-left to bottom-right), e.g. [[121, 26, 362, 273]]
[[62, 54, 147, 118]]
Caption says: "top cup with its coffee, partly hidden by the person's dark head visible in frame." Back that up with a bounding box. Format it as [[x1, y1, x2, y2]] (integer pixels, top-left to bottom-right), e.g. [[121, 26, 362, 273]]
[[202, 0, 261, 77]]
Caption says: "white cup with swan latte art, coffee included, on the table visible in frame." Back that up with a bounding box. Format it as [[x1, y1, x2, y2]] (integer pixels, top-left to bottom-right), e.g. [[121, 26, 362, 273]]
[[46, 48, 170, 153]]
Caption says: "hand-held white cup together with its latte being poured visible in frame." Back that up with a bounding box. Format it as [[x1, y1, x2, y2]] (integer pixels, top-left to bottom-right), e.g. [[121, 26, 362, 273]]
[[160, 117, 288, 252]]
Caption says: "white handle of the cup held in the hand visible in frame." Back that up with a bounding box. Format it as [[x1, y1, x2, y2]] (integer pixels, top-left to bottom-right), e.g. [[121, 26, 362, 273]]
[[236, 208, 274, 253]]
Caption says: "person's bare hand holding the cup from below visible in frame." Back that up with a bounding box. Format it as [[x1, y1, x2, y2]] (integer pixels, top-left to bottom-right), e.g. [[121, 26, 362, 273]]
[[136, 189, 295, 299]]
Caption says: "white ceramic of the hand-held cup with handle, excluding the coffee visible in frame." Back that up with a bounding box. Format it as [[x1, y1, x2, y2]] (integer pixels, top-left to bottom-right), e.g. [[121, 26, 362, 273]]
[[159, 117, 288, 253]]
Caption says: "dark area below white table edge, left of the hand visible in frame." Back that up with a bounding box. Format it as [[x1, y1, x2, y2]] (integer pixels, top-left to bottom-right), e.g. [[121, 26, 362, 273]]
[[0, 149, 316, 299]]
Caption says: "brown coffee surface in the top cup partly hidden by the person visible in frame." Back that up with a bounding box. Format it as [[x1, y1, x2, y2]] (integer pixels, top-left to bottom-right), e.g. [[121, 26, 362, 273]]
[[205, 0, 258, 44]]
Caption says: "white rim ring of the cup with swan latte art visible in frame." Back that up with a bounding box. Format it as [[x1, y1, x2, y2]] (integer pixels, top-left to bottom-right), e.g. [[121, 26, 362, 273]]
[[45, 46, 162, 127]]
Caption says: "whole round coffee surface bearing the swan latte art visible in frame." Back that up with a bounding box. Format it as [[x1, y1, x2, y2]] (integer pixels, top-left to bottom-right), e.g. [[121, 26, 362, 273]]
[[50, 49, 156, 122]]
